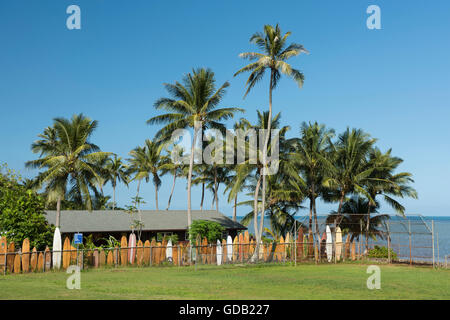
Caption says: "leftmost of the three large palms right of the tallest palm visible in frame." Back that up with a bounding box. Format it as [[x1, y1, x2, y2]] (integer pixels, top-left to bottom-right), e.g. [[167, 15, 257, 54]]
[[294, 122, 334, 246]]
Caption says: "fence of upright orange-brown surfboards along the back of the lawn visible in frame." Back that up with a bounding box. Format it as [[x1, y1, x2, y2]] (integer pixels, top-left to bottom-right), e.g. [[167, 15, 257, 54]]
[[0, 231, 358, 273]]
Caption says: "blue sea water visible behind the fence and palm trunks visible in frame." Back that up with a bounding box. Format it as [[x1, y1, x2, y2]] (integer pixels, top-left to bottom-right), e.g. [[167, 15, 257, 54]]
[[237, 215, 450, 262]]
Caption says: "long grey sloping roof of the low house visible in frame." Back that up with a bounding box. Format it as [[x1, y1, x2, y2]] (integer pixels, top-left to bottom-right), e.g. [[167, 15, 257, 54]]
[[46, 210, 246, 233]]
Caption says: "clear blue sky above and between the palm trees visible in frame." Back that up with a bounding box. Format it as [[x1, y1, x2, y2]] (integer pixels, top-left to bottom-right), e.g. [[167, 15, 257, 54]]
[[0, 0, 450, 215]]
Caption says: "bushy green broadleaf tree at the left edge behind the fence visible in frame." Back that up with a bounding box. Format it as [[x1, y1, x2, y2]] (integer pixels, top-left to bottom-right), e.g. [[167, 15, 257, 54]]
[[0, 165, 54, 250]]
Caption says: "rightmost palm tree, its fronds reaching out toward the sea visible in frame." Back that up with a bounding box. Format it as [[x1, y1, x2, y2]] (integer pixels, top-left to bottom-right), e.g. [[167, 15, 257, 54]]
[[364, 148, 417, 250]]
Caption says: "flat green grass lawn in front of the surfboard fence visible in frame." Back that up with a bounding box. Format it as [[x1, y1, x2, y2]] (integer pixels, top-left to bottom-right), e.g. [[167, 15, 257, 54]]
[[0, 264, 450, 300]]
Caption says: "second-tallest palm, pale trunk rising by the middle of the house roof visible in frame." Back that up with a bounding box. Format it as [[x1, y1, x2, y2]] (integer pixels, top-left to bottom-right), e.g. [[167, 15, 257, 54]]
[[147, 68, 244, 227]]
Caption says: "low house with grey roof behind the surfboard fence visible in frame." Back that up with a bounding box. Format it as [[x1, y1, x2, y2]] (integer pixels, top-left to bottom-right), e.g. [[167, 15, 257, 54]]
[[46, 210, 247, 243]]
